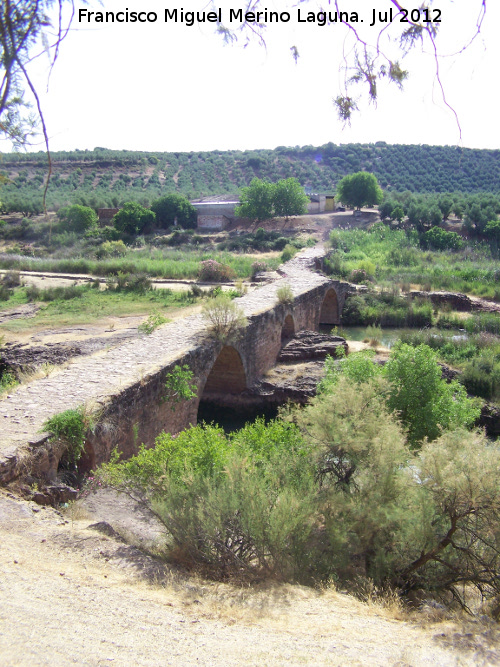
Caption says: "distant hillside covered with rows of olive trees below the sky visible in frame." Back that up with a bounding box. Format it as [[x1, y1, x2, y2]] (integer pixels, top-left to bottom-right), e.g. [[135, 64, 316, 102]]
[[0, 142, 500, 213]]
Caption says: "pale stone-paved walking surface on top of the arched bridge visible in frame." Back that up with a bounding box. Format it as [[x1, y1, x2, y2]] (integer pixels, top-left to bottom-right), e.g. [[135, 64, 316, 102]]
[[0, 247, 329, 482]]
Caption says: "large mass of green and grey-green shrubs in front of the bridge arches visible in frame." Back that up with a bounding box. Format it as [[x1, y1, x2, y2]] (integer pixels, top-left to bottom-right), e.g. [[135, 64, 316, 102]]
[[98, 344, 500, 615]]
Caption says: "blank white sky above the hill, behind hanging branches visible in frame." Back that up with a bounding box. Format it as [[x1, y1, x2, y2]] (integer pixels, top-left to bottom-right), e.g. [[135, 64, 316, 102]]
[[6, 0, 500, 151]]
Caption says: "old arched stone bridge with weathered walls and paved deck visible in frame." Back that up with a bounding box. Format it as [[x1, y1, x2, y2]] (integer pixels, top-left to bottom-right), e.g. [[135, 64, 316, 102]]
[[0, 248, 350, 483]]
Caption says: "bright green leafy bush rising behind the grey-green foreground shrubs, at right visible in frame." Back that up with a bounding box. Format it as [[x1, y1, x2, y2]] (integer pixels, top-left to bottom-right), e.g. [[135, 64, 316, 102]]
[[384, 343, 480, 446]]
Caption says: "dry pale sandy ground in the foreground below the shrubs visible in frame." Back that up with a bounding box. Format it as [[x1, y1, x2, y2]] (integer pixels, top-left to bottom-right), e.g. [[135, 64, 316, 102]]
[[0, 494, 500, 667]]
